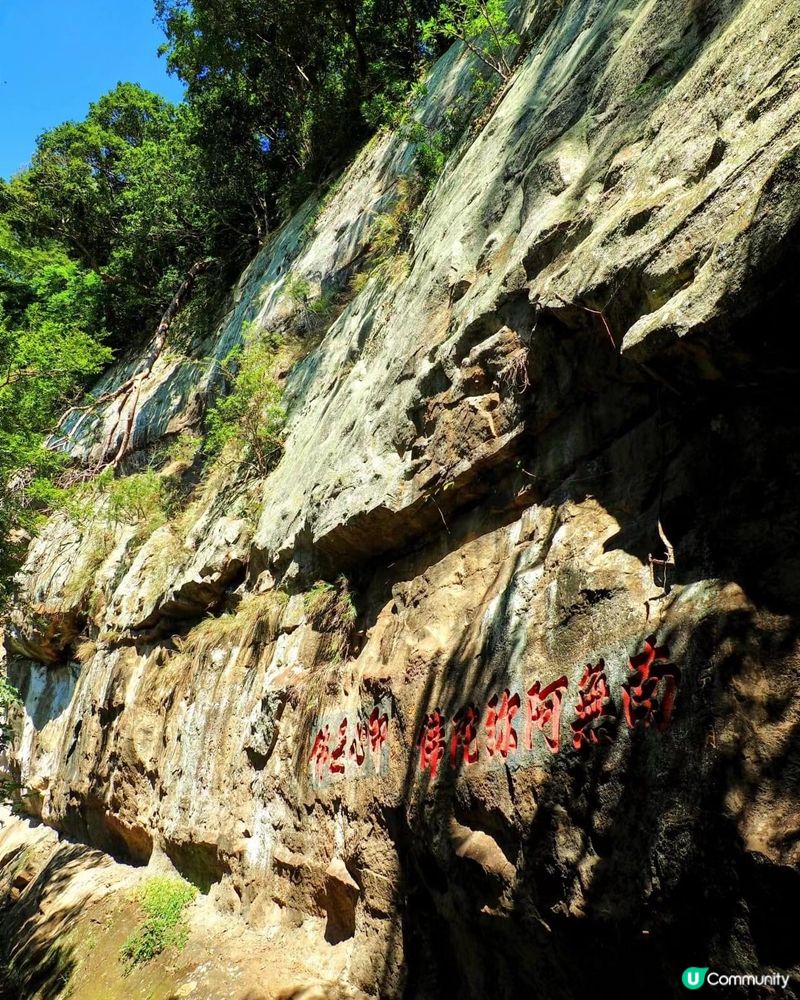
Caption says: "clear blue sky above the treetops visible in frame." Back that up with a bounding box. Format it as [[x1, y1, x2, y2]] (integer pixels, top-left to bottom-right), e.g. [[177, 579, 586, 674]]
[[0, 0, 182, 177]]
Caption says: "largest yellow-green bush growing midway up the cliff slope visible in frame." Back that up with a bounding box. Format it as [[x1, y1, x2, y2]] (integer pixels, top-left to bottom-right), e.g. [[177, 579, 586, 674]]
[[205, 333, 286, 475]]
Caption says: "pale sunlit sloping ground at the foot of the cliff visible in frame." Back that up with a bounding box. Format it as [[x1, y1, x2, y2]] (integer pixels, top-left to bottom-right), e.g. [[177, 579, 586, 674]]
[[0, 809, 364, 1000]]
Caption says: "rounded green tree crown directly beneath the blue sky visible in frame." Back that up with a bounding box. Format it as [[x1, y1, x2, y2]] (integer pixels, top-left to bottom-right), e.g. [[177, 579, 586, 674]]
[[0, 83, 214, 343]]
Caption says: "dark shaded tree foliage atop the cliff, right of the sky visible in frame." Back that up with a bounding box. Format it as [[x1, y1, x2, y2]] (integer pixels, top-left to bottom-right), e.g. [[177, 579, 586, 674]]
[[156, 0, 435, 211]]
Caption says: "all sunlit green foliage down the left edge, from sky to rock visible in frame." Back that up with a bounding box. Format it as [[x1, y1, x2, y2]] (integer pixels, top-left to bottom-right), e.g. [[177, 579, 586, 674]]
[[0, 84, 224, 596]]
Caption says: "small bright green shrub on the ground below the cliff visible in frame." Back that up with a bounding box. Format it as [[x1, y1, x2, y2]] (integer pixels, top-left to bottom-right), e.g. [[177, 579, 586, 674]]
[[120, 875, 197, 972]]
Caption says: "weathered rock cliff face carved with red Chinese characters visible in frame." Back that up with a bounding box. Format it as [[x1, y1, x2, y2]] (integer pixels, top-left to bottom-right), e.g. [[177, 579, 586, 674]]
[[1, 0, 800, 998]]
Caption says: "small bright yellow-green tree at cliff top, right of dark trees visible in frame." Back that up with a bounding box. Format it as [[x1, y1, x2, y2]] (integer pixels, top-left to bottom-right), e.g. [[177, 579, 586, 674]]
[[422, 0, 519, 80]]
